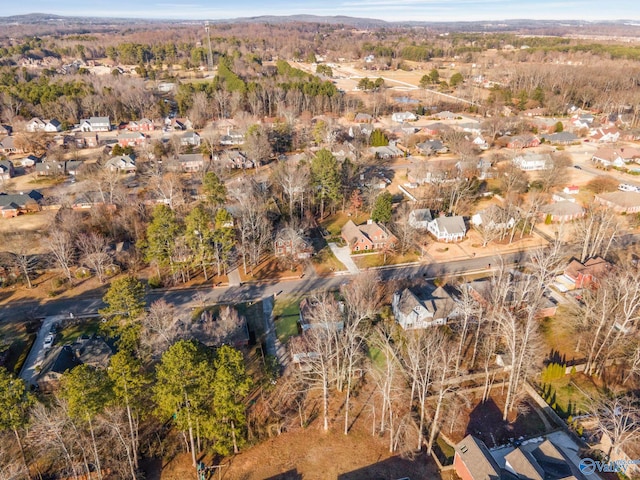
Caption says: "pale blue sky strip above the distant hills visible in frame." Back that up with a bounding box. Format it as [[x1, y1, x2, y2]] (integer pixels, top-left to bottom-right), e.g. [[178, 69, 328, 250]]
[[0, 0, 640, 21]]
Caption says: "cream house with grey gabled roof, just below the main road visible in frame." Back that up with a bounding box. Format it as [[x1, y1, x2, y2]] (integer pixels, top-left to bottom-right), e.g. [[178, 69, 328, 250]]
[[391, 287, 455, 330]]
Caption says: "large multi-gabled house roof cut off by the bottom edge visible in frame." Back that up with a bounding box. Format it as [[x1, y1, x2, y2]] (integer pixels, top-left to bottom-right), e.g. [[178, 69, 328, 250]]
[[453, 435, 584, 480]]
